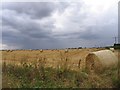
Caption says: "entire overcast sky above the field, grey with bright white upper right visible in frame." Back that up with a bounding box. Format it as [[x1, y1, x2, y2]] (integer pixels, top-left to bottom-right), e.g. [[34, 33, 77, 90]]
[[0, 0, 119, 49]]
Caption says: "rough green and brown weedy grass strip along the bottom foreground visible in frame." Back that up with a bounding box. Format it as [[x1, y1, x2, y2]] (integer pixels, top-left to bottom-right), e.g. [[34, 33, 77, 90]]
[[2, 64, 120, 88]]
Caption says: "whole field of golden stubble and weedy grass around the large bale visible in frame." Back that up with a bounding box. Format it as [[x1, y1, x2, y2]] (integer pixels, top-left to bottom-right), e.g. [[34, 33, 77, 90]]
[[1, 48, 120, 88]]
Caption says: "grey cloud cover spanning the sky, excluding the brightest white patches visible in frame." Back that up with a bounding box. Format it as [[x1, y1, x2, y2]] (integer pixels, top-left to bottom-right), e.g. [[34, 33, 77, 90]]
[[2, 2, 117, 49]]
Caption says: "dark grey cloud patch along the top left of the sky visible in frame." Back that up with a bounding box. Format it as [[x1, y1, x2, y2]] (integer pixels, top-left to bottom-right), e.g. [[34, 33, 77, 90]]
[[3, 2, 54, 19]]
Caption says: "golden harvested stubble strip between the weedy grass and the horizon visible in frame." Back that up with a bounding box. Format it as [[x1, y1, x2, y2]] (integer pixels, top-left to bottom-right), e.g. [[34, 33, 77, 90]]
[[2, 49, 105, 70]]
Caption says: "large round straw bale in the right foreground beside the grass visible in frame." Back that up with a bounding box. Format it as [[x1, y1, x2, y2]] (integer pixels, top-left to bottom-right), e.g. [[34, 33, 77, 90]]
[[86, 50, 118, 72]]
